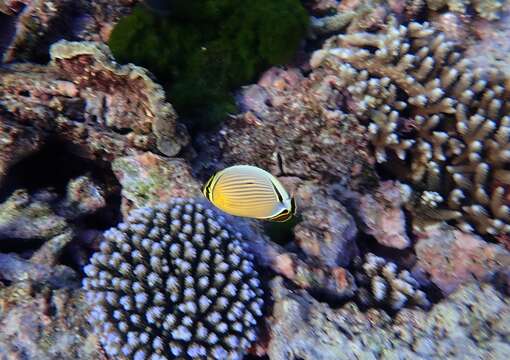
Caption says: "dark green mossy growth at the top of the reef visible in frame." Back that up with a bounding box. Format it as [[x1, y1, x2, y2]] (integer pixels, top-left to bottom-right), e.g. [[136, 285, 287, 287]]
[[109, 0, 308, 127]]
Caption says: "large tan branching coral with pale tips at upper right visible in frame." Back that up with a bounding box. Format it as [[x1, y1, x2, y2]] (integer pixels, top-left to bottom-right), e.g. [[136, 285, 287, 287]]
[[311, 21, 510, 236]]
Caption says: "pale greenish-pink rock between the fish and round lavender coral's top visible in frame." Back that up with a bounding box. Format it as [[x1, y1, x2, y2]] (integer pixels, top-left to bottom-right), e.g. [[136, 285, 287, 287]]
[[112, 153, 202, 214]]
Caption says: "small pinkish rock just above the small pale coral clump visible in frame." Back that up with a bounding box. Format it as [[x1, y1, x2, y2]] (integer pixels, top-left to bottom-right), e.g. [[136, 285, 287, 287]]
[[359, 181, 411, 249]]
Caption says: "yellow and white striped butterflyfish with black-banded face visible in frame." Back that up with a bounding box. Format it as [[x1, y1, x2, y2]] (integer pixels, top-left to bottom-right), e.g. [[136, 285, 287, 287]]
[[202, 165, 296, 222]]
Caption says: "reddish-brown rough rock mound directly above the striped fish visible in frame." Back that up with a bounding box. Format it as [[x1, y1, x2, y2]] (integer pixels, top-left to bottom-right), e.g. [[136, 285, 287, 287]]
[[219, 70, 371, 188]]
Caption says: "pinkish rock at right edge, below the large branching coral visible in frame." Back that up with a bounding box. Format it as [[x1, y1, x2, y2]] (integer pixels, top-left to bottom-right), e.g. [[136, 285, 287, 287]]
[[415, 225, 510, 294]]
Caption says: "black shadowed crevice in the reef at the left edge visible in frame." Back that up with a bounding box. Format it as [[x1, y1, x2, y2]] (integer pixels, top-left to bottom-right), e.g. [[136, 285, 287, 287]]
[[0, 140, 121, 252]]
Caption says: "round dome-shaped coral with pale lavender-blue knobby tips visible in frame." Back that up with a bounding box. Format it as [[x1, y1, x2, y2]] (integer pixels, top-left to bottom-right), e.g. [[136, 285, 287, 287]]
[[84, 199, 263, 360]]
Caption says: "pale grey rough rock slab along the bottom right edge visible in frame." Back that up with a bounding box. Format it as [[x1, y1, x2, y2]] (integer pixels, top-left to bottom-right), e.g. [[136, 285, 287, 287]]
[[267, 278, 510, 360]]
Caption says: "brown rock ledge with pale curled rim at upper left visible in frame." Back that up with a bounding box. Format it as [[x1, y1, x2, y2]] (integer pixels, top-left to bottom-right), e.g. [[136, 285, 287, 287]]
[[0, 41, 187, 183]]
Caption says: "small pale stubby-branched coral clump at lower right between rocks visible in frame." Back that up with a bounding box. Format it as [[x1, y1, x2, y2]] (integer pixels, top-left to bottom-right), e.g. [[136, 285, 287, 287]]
[[354, 253, 430, 310]]
